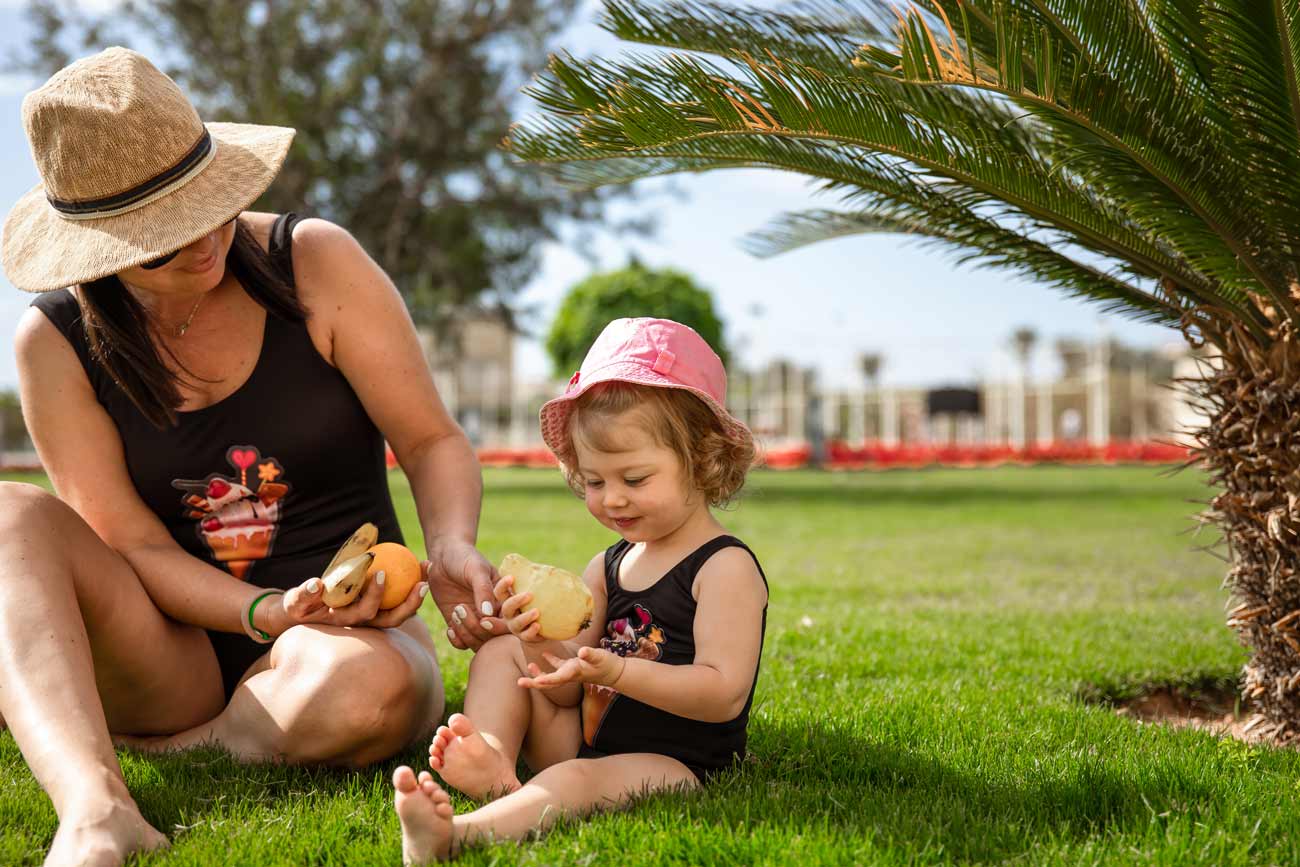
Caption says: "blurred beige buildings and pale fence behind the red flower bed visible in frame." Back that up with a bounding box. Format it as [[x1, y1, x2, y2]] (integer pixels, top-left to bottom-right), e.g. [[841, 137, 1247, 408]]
[[416, 323, 1197, 447]]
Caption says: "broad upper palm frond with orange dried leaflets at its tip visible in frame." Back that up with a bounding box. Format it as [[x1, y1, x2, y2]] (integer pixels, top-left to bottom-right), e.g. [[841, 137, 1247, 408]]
[[861, 0, 1294, 316]]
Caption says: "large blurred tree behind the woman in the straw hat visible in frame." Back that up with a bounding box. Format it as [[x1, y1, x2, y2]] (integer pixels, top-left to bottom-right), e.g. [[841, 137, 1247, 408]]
[[18, 0, 634, 324]]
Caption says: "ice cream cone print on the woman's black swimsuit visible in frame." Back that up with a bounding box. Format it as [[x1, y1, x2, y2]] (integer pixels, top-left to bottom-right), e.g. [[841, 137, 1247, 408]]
[[172, 446, 290, 578]]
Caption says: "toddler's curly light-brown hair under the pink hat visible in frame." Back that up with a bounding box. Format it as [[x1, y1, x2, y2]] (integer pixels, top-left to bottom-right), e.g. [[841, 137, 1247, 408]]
[[556, 381, 757, 506]]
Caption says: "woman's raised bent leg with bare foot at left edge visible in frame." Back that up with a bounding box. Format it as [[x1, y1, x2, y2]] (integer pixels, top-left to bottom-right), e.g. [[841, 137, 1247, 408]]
[[0, 482, 222, 864]]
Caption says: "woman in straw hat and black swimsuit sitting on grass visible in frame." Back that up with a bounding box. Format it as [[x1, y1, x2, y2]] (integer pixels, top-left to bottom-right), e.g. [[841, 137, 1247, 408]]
[[0, 48, 501, 864]]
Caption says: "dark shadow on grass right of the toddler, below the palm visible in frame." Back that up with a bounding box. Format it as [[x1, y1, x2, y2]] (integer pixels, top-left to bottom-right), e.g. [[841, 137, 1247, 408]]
[[710, 725, 1214, 863]]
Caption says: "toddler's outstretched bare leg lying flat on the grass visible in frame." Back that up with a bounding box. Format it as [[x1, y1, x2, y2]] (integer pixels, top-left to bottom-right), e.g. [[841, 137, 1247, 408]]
[[393, 753, 699, 864]]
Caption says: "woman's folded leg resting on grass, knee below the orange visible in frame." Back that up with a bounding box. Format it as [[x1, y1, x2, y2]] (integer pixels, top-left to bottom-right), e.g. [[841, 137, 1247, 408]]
[[129, 617, 445, 767]]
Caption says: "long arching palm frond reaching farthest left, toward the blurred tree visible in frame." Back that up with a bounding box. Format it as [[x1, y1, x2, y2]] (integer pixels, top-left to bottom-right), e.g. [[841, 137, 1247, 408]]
[[510, 49, 1261, 330]]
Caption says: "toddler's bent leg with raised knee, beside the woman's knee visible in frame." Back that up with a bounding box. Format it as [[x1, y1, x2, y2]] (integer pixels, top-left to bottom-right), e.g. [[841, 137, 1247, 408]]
[[429, 636, 581, 801]]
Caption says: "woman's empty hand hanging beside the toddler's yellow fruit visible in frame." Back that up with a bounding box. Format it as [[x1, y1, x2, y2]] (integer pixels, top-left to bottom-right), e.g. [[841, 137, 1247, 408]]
[[423, 536, 502, 650]]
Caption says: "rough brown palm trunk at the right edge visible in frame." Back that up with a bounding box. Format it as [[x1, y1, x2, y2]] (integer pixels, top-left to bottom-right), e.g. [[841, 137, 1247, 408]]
[[1197, 333, 1300, 742]]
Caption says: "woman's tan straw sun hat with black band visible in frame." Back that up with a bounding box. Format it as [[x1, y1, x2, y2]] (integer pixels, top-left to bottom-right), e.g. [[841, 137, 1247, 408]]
[[0, 48, 294, 292]]
